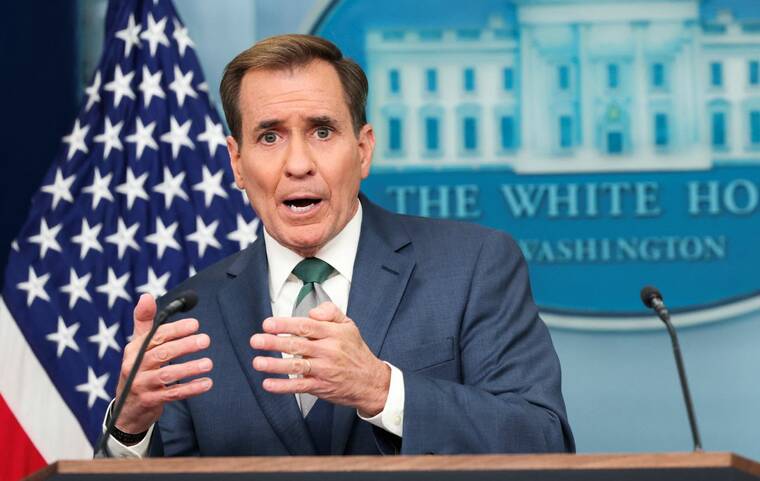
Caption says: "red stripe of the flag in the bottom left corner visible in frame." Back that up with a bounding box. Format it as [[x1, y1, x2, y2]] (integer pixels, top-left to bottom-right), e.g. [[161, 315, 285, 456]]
[[0, 395, 47, 481]]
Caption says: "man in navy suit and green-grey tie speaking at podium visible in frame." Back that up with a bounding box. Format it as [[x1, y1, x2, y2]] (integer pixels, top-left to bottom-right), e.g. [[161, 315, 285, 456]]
[[104, 35, 574, 456]]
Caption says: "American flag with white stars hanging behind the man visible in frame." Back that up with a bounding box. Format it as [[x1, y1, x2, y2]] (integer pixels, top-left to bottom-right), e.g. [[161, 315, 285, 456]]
[[0, 0, 258, 479]]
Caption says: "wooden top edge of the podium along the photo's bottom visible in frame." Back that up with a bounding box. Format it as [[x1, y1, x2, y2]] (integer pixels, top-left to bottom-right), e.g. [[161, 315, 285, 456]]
[[26, 452, 760, 481]]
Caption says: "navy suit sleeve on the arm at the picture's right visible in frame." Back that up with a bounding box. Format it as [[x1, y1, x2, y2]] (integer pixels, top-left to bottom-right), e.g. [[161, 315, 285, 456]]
[[394, 233, 575, 454]]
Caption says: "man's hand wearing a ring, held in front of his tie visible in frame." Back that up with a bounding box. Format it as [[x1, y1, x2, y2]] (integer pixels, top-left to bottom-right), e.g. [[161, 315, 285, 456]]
[[251, 302, 391, 417]]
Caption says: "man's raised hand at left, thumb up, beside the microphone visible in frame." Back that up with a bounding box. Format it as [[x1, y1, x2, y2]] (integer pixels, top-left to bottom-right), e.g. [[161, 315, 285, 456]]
[[116, 294, 213, 434]]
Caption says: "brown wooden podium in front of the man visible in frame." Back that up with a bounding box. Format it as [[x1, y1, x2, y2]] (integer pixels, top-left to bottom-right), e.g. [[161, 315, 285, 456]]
[[22, 453, 760, 481]]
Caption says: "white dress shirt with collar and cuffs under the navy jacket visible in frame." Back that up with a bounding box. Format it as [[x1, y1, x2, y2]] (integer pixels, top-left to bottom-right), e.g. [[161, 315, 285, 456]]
[[103, 204, 405, 457]]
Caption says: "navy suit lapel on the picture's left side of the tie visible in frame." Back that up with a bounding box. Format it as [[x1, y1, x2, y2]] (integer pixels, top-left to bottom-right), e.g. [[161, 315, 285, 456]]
[[219, 236, 316, 455]]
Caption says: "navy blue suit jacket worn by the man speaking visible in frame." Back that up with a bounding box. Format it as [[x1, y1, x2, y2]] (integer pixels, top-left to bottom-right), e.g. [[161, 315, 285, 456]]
[[151, 196, 574, 456]]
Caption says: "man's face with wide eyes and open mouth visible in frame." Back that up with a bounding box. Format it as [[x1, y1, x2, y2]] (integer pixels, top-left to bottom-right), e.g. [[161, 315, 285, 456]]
[[227, 60, 375, 257]]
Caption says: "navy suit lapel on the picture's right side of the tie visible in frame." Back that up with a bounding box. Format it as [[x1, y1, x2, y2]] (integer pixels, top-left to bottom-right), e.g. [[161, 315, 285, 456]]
[[331, 195, 414, 454]]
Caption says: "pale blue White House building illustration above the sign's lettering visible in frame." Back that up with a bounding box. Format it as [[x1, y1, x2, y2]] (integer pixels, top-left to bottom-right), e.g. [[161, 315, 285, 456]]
[[366, 0, 760, 172]]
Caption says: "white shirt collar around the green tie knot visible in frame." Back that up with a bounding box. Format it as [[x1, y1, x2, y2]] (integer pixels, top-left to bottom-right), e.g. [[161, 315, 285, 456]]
[[264, 202, 362, 300]]
